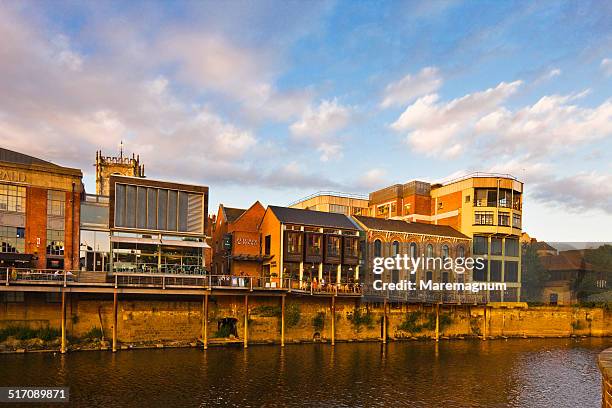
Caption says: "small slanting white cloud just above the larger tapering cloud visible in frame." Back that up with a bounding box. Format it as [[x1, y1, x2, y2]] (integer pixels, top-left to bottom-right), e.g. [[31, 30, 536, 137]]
[[380, 67, 442, 108]]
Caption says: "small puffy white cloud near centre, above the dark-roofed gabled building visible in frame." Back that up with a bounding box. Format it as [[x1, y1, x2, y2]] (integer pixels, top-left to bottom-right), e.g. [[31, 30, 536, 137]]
[[289, 99, 354, 161]]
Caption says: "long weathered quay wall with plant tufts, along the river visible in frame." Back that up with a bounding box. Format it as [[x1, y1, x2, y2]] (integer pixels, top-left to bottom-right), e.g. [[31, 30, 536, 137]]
[[0, 292, 612, 344]]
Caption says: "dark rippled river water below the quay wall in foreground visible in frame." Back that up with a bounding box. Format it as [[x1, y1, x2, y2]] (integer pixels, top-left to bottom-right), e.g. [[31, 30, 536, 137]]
[[0, 338, 612, 408]]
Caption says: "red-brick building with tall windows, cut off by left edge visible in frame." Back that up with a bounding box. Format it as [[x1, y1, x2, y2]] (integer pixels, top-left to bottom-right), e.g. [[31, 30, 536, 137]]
[[0, 148, 83, 269]]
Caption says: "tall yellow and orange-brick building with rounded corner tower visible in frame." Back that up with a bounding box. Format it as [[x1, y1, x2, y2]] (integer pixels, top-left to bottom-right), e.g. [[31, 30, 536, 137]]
[[369, 173, 523, 302]]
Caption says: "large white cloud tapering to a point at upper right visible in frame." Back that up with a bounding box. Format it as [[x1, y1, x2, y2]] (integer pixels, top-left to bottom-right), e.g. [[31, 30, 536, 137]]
[[391, 81, 522, 157]]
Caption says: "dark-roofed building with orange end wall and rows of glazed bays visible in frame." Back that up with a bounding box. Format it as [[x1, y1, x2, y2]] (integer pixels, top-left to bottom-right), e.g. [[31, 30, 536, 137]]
[[260, 206, 361, 284]]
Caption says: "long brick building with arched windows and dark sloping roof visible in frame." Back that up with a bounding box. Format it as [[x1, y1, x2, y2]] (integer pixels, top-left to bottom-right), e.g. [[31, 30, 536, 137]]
[[354, 216, 472, 286]]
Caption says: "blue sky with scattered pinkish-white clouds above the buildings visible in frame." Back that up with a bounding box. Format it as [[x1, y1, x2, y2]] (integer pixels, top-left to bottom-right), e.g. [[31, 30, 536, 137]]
[[0, 0, 612, 241]]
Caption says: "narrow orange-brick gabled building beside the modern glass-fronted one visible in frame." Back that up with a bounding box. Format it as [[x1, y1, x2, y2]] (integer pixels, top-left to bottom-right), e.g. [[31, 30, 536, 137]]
[[212, 201, 266, 276]]
